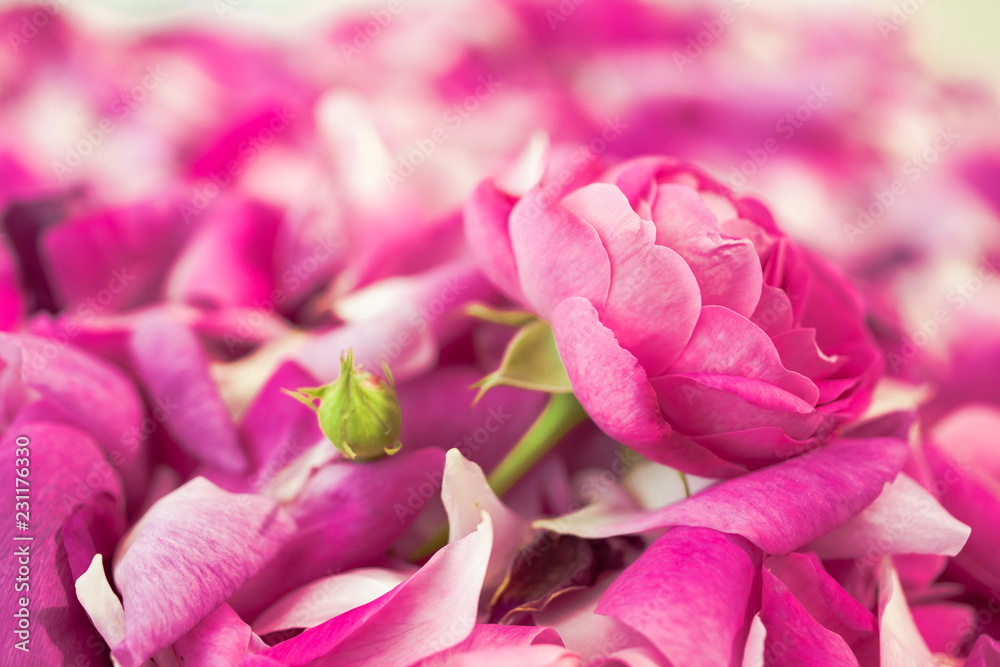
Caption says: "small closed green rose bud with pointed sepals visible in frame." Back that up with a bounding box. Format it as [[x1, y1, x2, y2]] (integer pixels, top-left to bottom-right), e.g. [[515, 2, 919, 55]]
[[282, 350, 403, 461]]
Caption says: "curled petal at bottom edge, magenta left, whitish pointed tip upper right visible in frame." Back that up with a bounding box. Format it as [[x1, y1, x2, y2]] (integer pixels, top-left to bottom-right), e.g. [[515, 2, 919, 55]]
[[264, 515, 493, 667]]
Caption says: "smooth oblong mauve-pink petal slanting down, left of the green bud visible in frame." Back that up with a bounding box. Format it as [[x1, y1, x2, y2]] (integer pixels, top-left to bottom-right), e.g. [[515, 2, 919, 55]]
[[131, 314, 247, 472]]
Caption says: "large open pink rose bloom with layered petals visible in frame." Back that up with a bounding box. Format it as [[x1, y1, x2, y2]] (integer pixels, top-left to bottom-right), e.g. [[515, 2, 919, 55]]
[[465, 158, 881, 477]]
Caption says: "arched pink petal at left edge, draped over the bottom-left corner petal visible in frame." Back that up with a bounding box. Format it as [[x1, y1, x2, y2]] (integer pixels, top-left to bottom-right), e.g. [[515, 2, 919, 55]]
[[0, 333, 148, 505]]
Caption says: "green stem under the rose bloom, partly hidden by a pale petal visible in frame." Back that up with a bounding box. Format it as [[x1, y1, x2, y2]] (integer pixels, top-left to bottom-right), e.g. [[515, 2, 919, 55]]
[[410, 393, 587, 562]]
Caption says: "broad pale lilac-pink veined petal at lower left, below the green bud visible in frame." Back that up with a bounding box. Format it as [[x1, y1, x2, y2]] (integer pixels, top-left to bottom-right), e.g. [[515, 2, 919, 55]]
[[114, 477, 294, 667]]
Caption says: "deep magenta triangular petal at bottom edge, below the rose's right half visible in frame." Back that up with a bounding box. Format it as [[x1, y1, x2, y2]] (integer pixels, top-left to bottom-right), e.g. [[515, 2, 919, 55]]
[[760, 570, 858, 667]]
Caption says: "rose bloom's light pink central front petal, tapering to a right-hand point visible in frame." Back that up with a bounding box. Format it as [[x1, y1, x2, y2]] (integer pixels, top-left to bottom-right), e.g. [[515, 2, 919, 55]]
[[669, 306, 819, 405]]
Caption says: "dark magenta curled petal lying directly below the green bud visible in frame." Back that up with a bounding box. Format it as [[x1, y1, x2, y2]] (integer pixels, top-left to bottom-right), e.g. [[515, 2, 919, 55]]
[[230, 448, 444, 619]]
